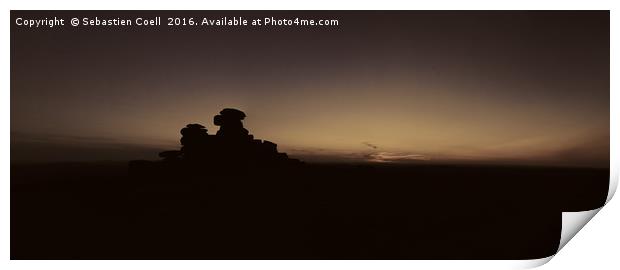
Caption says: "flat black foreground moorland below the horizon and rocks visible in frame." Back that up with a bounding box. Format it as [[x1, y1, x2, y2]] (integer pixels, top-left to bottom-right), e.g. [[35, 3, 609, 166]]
[[11, 163, 609, 259]]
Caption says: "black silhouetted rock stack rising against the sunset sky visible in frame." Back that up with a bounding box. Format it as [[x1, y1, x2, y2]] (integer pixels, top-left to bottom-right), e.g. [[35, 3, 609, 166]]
[[130, 108, 300, 168]]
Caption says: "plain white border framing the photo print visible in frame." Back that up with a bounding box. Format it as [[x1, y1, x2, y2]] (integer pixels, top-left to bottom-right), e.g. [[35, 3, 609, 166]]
[[0, 0, 620, 269]]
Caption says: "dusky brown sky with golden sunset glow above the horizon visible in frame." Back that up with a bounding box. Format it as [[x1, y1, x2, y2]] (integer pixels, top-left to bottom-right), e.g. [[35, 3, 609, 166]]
[[11, 11, 610, 167]]
